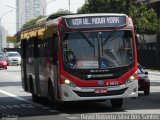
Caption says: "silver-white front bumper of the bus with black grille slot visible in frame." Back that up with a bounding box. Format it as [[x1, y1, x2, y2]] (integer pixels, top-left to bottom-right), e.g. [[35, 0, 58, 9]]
[[61, 80, 138, 101]]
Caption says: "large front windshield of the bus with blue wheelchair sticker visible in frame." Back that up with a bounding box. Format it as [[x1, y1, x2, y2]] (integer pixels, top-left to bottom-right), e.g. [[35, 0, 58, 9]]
[[62, 30, 134, 69]]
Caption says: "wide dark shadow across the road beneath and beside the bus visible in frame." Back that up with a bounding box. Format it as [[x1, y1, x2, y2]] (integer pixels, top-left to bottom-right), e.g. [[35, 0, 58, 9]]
[[0, 92, 160, 117]]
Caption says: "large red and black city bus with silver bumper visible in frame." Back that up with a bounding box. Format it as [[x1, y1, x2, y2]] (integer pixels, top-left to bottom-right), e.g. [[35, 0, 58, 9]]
[[20, 13, 138, 107]]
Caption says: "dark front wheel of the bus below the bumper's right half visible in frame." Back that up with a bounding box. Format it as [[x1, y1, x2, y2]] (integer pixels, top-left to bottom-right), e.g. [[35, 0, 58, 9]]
[[111, 98, 123, 108]]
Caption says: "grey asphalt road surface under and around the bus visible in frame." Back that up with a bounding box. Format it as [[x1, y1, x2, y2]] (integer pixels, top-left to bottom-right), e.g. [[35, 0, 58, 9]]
[[0, 66, 160, 120]]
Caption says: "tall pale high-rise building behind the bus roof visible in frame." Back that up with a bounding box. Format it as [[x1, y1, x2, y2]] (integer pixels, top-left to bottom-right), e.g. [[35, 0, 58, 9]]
[[16, 0, 46, 31]]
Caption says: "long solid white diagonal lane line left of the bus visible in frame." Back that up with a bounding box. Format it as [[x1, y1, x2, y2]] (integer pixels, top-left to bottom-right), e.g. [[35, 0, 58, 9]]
[[0, 89, 59, 112]]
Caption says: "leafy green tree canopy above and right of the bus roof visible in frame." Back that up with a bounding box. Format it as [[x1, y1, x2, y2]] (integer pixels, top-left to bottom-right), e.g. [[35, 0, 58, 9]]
[[77, 0, 160, 33]]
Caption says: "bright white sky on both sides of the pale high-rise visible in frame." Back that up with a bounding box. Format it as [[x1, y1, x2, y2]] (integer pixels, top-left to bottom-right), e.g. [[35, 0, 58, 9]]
[[0, 0, 85, 35]]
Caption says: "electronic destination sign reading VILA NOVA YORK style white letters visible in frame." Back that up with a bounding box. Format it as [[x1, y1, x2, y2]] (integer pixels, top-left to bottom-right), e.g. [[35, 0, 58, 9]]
[[66, 16, 126, 28]]
